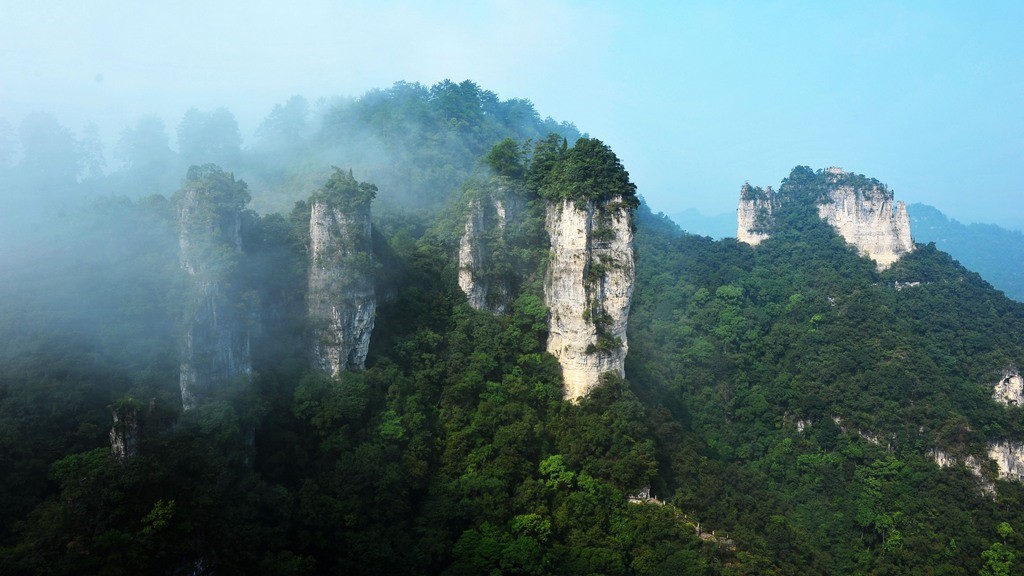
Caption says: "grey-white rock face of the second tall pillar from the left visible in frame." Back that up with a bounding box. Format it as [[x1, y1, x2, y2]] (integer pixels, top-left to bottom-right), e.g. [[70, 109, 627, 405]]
[[306, 201, 377, 376]]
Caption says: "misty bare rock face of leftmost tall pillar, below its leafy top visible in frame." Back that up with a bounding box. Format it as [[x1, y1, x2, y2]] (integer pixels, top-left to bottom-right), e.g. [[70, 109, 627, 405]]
[[178, 189, 252, 410]]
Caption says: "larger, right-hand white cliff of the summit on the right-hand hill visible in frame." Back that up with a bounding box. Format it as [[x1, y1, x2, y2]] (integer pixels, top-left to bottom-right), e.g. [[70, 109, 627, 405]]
[[818, 168, 913, 270]]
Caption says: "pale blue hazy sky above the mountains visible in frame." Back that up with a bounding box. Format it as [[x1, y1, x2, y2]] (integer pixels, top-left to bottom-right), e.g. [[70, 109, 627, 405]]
[[0, 0, 1024, 229]]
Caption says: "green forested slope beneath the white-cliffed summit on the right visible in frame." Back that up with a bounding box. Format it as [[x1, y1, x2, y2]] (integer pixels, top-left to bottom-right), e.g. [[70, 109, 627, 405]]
[[627, 188, 1024, 574]]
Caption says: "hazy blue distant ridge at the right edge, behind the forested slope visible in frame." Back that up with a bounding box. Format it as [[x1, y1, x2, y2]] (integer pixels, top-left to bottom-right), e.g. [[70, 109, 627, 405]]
[[907, 204, 1024, 301]]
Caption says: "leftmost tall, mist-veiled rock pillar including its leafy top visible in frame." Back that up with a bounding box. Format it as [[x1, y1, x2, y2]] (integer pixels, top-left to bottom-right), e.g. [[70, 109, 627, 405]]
[[175, 165, 253, 410]]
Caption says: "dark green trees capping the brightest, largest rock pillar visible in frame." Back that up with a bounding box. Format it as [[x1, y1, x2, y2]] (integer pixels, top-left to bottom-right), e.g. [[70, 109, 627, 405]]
[[540, 138, 640, 209]]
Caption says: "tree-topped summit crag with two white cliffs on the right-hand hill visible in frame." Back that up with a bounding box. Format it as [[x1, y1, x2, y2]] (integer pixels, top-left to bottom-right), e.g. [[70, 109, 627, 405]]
[[736, 167, 913, 270]]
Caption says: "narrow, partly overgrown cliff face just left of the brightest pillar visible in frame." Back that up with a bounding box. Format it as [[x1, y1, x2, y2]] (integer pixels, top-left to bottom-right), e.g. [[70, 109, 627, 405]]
[[459, 188, 519, 314]]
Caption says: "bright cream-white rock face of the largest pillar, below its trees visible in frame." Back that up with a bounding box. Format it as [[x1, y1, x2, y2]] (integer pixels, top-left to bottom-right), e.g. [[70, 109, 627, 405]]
[[544, 197, 635, 401]]
